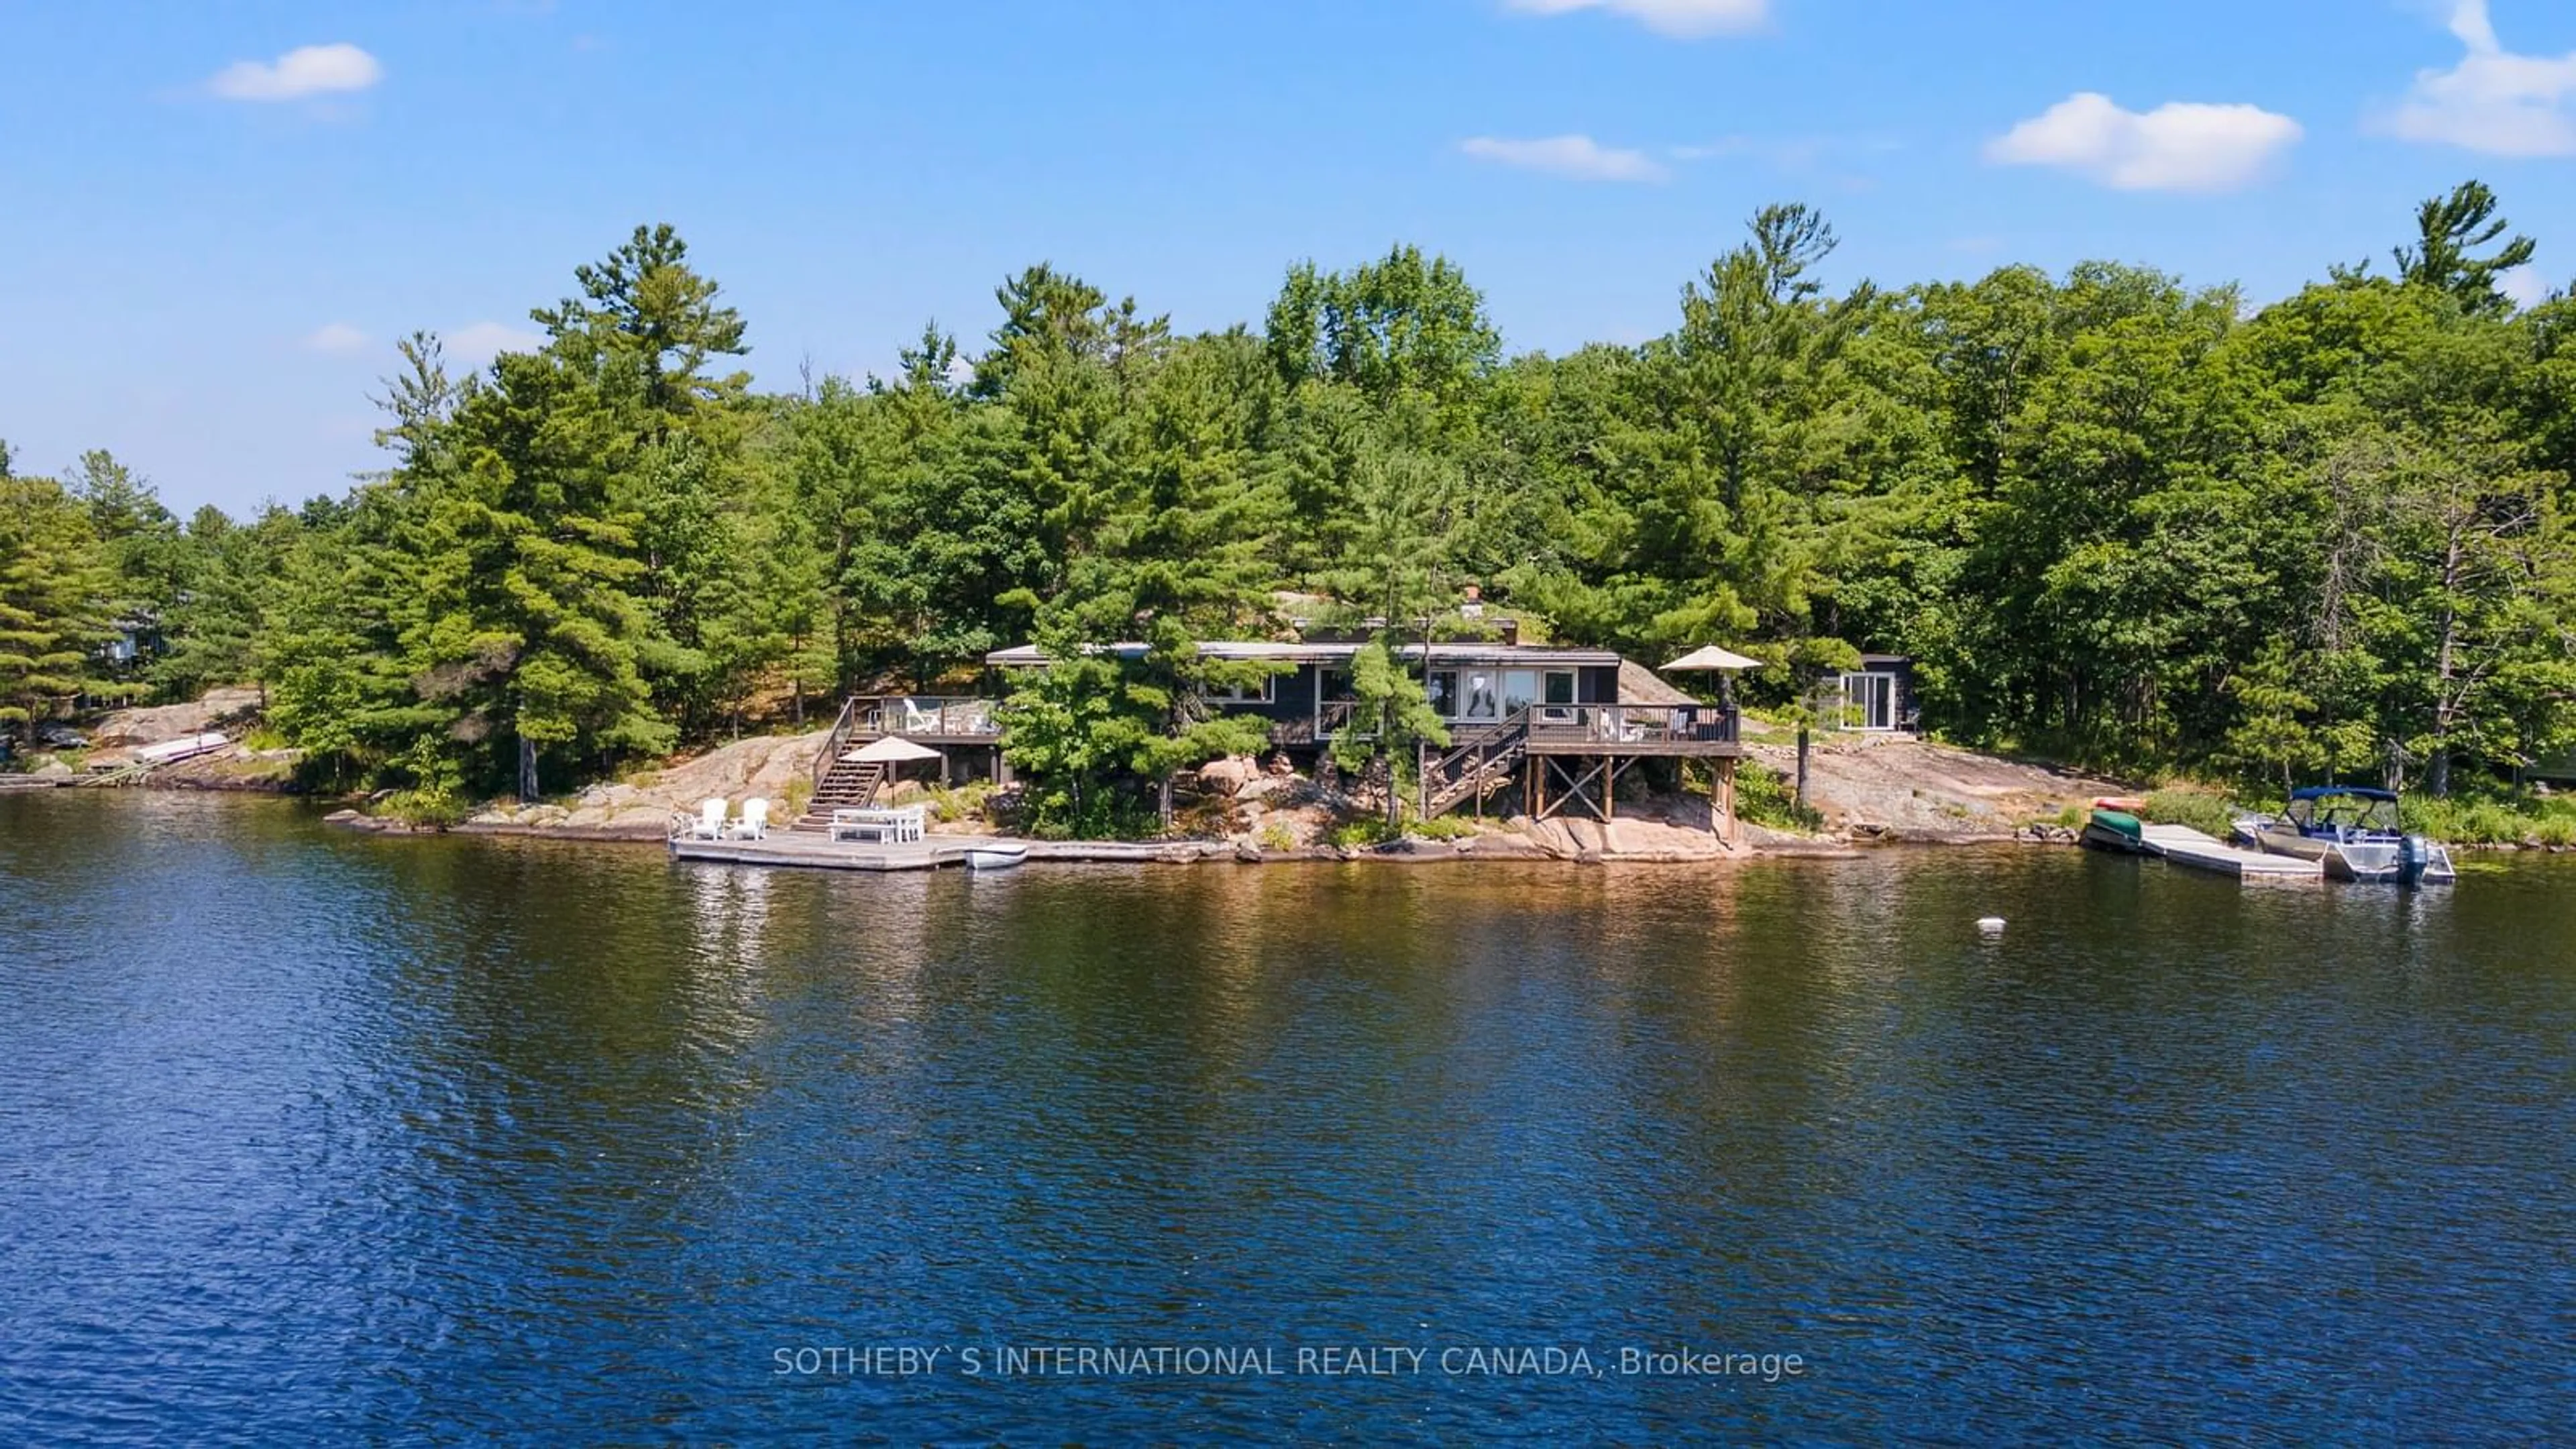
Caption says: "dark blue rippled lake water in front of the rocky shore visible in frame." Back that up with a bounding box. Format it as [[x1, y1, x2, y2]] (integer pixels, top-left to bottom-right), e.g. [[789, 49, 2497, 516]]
[[0, 792, 2576, 1444]]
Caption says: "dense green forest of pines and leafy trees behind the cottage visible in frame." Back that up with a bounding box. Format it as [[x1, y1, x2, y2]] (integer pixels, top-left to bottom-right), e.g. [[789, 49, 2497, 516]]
[[0, 183, 2576, 830]]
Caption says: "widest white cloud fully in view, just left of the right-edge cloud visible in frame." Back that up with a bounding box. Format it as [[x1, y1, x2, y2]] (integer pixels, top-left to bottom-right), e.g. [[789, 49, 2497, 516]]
[[1986, 91, 2306, 191]]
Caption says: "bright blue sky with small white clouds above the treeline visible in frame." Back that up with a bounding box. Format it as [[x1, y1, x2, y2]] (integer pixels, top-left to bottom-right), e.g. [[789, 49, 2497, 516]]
[[0, 0, 2576, 513]]
